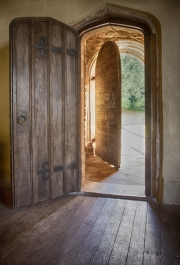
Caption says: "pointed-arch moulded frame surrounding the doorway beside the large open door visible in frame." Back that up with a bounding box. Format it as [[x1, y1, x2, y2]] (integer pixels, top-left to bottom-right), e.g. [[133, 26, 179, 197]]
[[73, 4, 163, 198]]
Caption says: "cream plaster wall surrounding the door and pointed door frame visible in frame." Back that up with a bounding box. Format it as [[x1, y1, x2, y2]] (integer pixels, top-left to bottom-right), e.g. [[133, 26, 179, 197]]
[[0, 0, 180, 204]]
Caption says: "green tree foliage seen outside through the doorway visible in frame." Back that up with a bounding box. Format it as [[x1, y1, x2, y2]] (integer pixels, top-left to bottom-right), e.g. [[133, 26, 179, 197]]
[[121, 54, 145, 111]]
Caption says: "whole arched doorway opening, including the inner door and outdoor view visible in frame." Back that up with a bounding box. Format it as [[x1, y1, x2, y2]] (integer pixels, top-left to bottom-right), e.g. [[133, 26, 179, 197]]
[[82, 25, 145, 197]]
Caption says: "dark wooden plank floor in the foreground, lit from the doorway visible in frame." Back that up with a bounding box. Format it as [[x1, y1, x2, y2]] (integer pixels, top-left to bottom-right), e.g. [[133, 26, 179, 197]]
[[0, 196, 180, 265]]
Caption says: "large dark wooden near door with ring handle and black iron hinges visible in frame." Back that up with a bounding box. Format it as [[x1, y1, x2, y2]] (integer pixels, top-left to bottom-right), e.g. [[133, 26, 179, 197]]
[[10, 18, 80, 207]]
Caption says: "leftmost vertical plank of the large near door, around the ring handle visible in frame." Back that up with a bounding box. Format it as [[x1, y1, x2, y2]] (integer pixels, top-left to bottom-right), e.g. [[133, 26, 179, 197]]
[[12, 22, 31, 206]]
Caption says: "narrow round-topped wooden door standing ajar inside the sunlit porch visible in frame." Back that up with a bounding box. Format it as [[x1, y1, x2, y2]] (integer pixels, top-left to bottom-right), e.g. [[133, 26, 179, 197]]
[[95, 41, 121, 168]]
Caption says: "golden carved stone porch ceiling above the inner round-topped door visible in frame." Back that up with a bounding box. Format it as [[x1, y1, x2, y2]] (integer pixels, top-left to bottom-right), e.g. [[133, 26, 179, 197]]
[[84, 25, 144, 65]]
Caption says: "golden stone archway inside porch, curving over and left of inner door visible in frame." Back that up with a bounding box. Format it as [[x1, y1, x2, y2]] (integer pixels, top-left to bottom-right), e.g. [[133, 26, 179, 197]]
[[81, 26, 144, 143]]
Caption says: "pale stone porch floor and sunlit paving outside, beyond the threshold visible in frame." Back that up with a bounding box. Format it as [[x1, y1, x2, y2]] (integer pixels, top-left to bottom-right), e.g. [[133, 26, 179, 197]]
[[82, 120, 145, 197]]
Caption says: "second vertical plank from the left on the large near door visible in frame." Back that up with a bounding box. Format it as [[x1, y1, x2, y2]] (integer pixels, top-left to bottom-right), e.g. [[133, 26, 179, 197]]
[[33, 21, 50, 203]]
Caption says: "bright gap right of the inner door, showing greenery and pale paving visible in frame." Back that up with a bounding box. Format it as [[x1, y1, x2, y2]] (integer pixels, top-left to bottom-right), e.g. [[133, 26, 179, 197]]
[[120, 54, 145, 196]]
